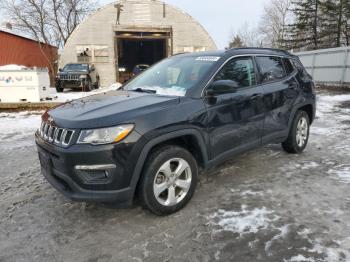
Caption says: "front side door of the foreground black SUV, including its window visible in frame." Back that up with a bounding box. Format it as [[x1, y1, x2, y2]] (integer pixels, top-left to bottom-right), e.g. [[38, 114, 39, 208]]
[[205, 57, 264, 160]]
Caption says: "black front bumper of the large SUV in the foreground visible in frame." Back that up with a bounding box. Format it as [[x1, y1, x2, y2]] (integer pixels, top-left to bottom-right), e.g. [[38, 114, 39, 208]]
[[35, 133, 139, 205]]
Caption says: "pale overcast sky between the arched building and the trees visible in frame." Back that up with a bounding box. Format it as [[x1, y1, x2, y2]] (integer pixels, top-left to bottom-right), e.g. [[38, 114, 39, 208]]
[[0, 0, 269, 49]]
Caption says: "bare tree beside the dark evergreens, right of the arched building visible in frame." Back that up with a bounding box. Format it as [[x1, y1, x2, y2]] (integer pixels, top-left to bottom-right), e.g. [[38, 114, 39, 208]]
[[259, 0, 292, 48]]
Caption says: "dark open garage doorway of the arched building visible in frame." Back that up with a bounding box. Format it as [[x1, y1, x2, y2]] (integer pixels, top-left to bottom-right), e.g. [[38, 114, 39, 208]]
[[117, 38, 167, 83]]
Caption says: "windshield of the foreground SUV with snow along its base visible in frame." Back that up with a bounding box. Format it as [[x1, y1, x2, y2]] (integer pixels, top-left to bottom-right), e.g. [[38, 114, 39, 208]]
[[124, 56, 220, 96]]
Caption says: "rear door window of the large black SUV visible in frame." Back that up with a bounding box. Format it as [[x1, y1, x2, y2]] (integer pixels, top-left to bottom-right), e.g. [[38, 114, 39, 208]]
[[256, 56, 286, 83]]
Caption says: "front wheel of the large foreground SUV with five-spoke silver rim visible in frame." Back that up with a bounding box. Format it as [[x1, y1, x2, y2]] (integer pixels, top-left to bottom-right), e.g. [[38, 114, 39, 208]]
[[138, 145, 198, 216]]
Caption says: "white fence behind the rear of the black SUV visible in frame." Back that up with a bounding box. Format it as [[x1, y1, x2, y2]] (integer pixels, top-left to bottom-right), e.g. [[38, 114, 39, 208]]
[[295, 47, 350, 85]]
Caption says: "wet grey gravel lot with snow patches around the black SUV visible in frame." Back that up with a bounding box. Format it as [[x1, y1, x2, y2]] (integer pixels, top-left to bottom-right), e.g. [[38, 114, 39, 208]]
[[0, 91, 350, 262]]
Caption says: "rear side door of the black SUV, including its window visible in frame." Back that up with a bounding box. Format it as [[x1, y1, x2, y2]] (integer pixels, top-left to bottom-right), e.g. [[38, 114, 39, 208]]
[[255, 56, 299, 143]]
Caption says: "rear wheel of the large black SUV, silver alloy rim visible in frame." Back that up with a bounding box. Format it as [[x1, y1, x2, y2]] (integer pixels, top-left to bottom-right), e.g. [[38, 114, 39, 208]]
[[282, 110, 310, 154]]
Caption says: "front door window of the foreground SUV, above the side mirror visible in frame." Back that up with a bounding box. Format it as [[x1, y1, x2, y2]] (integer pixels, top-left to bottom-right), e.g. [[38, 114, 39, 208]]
[[214, 57, 256, 88]]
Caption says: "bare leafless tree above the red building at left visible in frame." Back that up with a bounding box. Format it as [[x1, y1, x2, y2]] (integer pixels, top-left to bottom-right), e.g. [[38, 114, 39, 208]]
[[0, 0, 97, 47]]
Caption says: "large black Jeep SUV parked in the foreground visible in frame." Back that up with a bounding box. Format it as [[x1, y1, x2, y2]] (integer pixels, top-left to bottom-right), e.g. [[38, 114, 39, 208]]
[[36, 49, 315, 215]]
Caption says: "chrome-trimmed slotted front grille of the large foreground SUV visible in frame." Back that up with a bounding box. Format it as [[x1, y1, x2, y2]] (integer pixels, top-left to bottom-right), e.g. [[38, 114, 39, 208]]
[[39, 122, 74, 147]]
